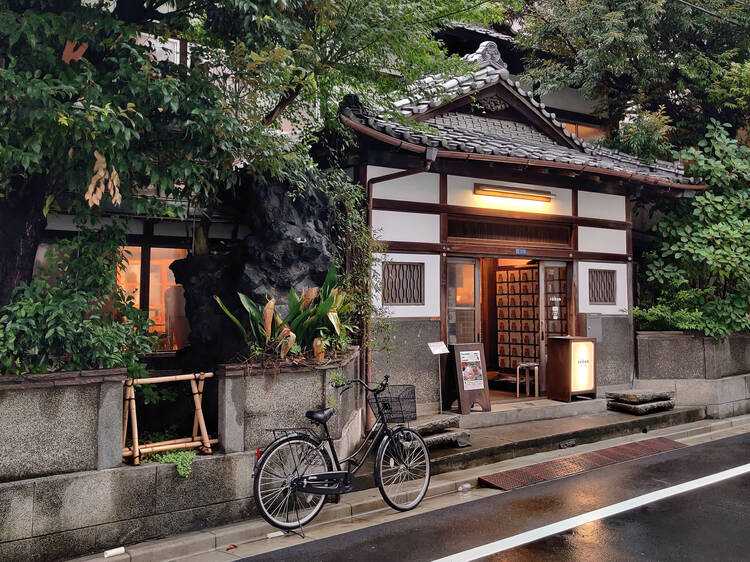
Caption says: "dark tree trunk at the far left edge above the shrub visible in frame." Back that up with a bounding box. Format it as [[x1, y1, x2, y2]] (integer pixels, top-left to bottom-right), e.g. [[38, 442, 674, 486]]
[[0, 176, 47, 306]]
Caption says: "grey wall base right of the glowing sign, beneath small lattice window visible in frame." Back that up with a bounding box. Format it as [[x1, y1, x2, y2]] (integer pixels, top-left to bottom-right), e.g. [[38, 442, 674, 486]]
[[586, 314, 634, 386]]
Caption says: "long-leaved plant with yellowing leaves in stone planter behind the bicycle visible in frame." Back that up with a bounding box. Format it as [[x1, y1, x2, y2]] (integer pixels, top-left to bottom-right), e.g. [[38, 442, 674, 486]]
[[214, 266, 354, 360]]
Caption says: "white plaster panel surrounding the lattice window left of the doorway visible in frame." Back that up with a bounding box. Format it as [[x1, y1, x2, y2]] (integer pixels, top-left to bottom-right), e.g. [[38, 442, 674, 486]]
[[372, 253, 440, 318]]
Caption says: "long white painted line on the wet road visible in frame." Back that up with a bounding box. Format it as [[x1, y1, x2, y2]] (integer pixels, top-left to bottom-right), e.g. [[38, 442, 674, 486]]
[[434, 464, 750, 562]]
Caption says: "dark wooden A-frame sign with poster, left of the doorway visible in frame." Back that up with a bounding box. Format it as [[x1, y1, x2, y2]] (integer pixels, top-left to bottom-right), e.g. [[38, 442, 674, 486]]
[[451, 343, 492, 414]]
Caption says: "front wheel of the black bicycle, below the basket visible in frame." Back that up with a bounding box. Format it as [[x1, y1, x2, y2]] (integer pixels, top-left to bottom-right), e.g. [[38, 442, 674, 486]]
[[375, 427, 430, 511]]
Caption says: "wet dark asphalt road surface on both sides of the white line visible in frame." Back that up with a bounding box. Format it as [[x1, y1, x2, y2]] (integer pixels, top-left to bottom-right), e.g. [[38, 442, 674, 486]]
[[247, 434, 750, 562]]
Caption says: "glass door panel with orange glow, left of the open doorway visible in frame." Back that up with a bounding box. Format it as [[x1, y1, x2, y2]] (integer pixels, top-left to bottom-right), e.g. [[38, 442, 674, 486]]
[[447, 259, 479, 344]]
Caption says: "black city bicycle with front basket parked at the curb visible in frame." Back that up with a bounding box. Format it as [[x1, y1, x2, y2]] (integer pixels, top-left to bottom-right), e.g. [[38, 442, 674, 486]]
[[253, 375, 430, 531]]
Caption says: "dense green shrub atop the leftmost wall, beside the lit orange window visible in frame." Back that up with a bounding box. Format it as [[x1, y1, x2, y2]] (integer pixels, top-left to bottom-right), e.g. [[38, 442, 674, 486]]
[[0, 224, 157, 375]]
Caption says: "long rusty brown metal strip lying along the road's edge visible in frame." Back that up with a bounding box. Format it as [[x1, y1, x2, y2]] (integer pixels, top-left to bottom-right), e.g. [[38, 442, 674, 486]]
[[479, 437, 686, 490]]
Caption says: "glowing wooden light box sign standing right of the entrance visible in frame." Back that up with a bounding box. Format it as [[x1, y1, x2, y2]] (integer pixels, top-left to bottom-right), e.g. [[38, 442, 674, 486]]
[[547, 336, 596, 402]]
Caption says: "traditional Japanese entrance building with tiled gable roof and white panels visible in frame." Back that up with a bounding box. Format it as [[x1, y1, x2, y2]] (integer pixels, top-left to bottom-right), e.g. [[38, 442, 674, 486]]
[[341, 41, 705, 412]]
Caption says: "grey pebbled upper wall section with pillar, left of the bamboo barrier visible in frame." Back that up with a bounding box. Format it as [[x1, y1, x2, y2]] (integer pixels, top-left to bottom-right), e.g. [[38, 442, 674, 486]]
[[0, 369, 125, 482]]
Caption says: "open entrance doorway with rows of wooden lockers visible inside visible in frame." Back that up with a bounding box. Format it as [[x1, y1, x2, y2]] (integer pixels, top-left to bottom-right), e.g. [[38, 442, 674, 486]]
[[446, 257, 570, 402]]
